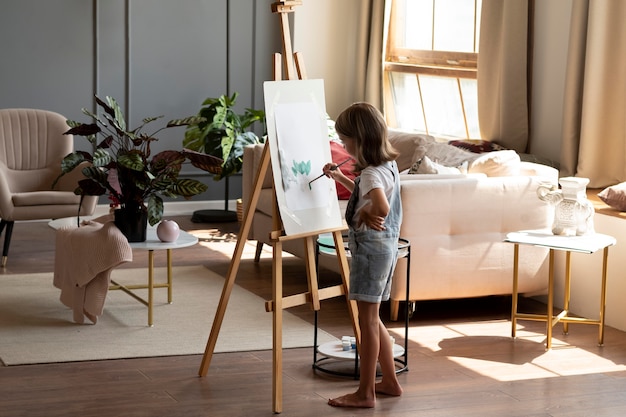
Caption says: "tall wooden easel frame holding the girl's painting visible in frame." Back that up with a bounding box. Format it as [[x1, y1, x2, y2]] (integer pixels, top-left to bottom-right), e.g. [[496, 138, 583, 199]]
[[198, 0, 361, 413]]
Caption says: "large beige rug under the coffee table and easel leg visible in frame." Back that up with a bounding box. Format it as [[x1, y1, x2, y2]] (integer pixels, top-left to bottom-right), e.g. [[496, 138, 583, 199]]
[[0, 266, 336, 365]]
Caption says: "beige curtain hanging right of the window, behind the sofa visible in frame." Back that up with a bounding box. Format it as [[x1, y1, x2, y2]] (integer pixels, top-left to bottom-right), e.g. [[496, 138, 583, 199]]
[[478, 0, 529, 152]]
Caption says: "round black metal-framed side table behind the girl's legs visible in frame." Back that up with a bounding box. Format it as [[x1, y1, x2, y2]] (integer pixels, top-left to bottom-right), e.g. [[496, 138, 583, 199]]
[[313, 238, 411, 379]]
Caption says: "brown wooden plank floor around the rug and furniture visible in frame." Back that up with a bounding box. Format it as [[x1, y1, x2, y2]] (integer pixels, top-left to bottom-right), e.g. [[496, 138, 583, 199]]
[[0, 216, 626, 417]]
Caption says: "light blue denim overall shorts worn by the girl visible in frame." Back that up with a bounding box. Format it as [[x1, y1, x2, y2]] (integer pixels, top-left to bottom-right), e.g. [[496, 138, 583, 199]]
[[345, 162, 402, 303]]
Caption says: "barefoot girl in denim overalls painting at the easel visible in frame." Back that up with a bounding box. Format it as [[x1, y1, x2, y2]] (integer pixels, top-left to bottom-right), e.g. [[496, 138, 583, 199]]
[[323, 103, 402, 408]]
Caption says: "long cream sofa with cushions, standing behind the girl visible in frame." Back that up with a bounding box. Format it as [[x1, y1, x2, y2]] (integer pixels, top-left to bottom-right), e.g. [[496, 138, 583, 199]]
[[243, 130, 558, 320]]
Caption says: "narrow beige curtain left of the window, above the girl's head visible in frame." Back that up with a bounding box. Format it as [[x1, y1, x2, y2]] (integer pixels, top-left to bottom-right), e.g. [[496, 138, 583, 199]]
[[354, 0, 385, 111]]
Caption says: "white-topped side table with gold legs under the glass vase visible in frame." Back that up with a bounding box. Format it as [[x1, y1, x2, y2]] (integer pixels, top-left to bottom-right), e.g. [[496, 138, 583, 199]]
[[504, 230, 616, 349]]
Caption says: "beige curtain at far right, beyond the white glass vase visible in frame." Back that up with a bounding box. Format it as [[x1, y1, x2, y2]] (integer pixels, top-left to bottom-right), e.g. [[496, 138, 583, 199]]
[[561, 0, 626, 188]]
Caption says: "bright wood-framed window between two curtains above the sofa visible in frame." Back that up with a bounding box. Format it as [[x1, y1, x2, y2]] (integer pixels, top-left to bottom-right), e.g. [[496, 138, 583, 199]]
[[384, 0, 482, 139]]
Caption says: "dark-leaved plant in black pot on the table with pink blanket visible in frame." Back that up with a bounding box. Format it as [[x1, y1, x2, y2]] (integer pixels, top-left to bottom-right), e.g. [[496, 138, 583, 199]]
[[57, 97, 207, 242]]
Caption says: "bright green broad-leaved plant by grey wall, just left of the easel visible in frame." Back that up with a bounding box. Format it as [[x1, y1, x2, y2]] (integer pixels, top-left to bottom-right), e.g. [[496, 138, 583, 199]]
[[183, 92, 265, 181]]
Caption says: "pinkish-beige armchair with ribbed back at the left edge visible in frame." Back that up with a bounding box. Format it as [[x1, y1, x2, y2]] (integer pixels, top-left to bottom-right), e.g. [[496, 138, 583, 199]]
[[0, 109, 97, 267]]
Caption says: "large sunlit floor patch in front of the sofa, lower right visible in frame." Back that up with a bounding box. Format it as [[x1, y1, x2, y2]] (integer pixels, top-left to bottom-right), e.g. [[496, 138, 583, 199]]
[[390, 320, 626, 381]]
